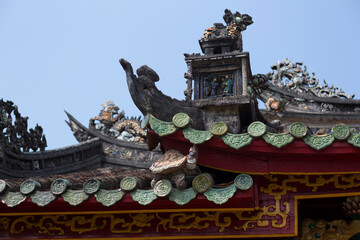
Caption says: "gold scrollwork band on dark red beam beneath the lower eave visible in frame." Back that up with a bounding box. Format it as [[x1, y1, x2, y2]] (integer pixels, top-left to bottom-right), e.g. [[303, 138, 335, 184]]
[[0, 198, 290, 237]]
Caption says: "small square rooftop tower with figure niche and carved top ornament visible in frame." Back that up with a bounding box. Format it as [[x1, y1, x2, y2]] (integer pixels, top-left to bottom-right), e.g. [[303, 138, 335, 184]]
[[184, 9, 260, 133]]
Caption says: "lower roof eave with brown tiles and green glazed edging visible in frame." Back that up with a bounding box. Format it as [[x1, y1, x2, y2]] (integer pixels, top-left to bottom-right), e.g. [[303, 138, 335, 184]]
[[0, 168, 254, 208]]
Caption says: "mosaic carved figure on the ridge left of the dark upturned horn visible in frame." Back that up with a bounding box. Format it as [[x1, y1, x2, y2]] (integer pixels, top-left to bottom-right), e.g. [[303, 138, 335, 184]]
[[90, 100, 146, 143]]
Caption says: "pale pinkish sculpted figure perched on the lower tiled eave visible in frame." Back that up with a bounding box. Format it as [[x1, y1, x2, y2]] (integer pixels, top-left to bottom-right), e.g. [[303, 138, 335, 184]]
[[150, 145, 201, 190]]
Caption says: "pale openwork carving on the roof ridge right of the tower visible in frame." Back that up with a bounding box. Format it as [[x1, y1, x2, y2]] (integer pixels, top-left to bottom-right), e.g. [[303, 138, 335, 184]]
[[267, 58, 355, 99]]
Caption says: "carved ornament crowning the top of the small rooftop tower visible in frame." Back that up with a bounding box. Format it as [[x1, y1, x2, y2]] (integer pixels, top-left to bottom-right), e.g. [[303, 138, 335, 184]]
[[199, 9, 253, 55]]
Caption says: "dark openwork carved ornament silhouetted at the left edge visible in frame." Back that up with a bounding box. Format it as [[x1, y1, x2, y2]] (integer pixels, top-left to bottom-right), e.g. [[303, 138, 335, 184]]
[[0, 99, 47, 153]]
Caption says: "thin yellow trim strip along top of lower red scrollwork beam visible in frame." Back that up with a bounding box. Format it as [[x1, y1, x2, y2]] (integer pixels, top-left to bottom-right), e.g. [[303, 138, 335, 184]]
[[0, 208, 255, 217]]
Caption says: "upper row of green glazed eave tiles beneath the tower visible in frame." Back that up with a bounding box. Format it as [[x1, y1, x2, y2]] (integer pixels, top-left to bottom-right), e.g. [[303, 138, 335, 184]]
[[150, 115, 360, 150]]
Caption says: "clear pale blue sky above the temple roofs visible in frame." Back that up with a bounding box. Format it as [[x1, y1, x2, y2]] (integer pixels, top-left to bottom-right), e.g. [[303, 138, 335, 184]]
[[0, 0, 360, 149]]
